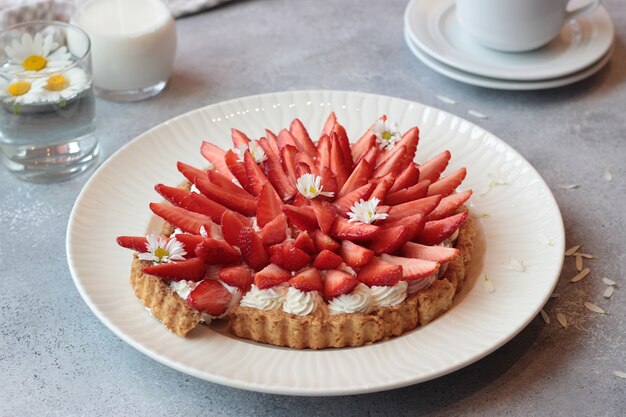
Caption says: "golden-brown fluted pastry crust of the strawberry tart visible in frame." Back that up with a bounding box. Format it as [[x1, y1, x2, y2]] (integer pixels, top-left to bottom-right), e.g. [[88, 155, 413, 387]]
[[130, 207, 475, 349]]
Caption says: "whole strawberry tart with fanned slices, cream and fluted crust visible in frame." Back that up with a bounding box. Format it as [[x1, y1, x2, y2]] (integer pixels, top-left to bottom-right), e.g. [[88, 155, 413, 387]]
[[117, 113, 474, 349]]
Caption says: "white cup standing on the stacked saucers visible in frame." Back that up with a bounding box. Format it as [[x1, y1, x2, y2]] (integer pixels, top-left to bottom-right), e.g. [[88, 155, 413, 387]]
[[456, 0, 601, 52]]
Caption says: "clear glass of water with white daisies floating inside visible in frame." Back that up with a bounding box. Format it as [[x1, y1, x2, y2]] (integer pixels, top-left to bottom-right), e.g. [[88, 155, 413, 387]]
[[0, 21, 99, 182]]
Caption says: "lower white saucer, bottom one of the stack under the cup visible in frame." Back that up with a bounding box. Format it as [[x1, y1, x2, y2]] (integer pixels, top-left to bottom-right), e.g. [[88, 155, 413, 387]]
[[404, 28, 613, 90]]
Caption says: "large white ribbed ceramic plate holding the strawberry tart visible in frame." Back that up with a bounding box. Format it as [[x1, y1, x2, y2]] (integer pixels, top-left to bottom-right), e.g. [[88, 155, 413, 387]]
[[67, 91, 564, 395]]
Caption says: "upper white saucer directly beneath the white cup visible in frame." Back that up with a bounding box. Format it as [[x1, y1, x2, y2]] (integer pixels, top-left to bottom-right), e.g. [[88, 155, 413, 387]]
[[404, 0, 614, 81]]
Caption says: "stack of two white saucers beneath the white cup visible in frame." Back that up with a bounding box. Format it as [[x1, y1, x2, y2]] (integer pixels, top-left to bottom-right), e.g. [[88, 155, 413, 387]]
[[404, 0, 614, 90]]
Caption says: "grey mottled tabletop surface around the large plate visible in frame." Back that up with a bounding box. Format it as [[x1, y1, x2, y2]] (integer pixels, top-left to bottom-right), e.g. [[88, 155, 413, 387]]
[[0, 0, 626, 416]]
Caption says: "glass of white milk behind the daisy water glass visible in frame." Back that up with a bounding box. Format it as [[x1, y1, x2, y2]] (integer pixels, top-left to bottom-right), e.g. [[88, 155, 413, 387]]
[[71, 0, 176, 101]]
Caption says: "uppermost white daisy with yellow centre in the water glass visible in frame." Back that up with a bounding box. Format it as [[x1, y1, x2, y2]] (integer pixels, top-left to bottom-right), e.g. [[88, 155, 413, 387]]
[[4, 33, 72, 74]]
